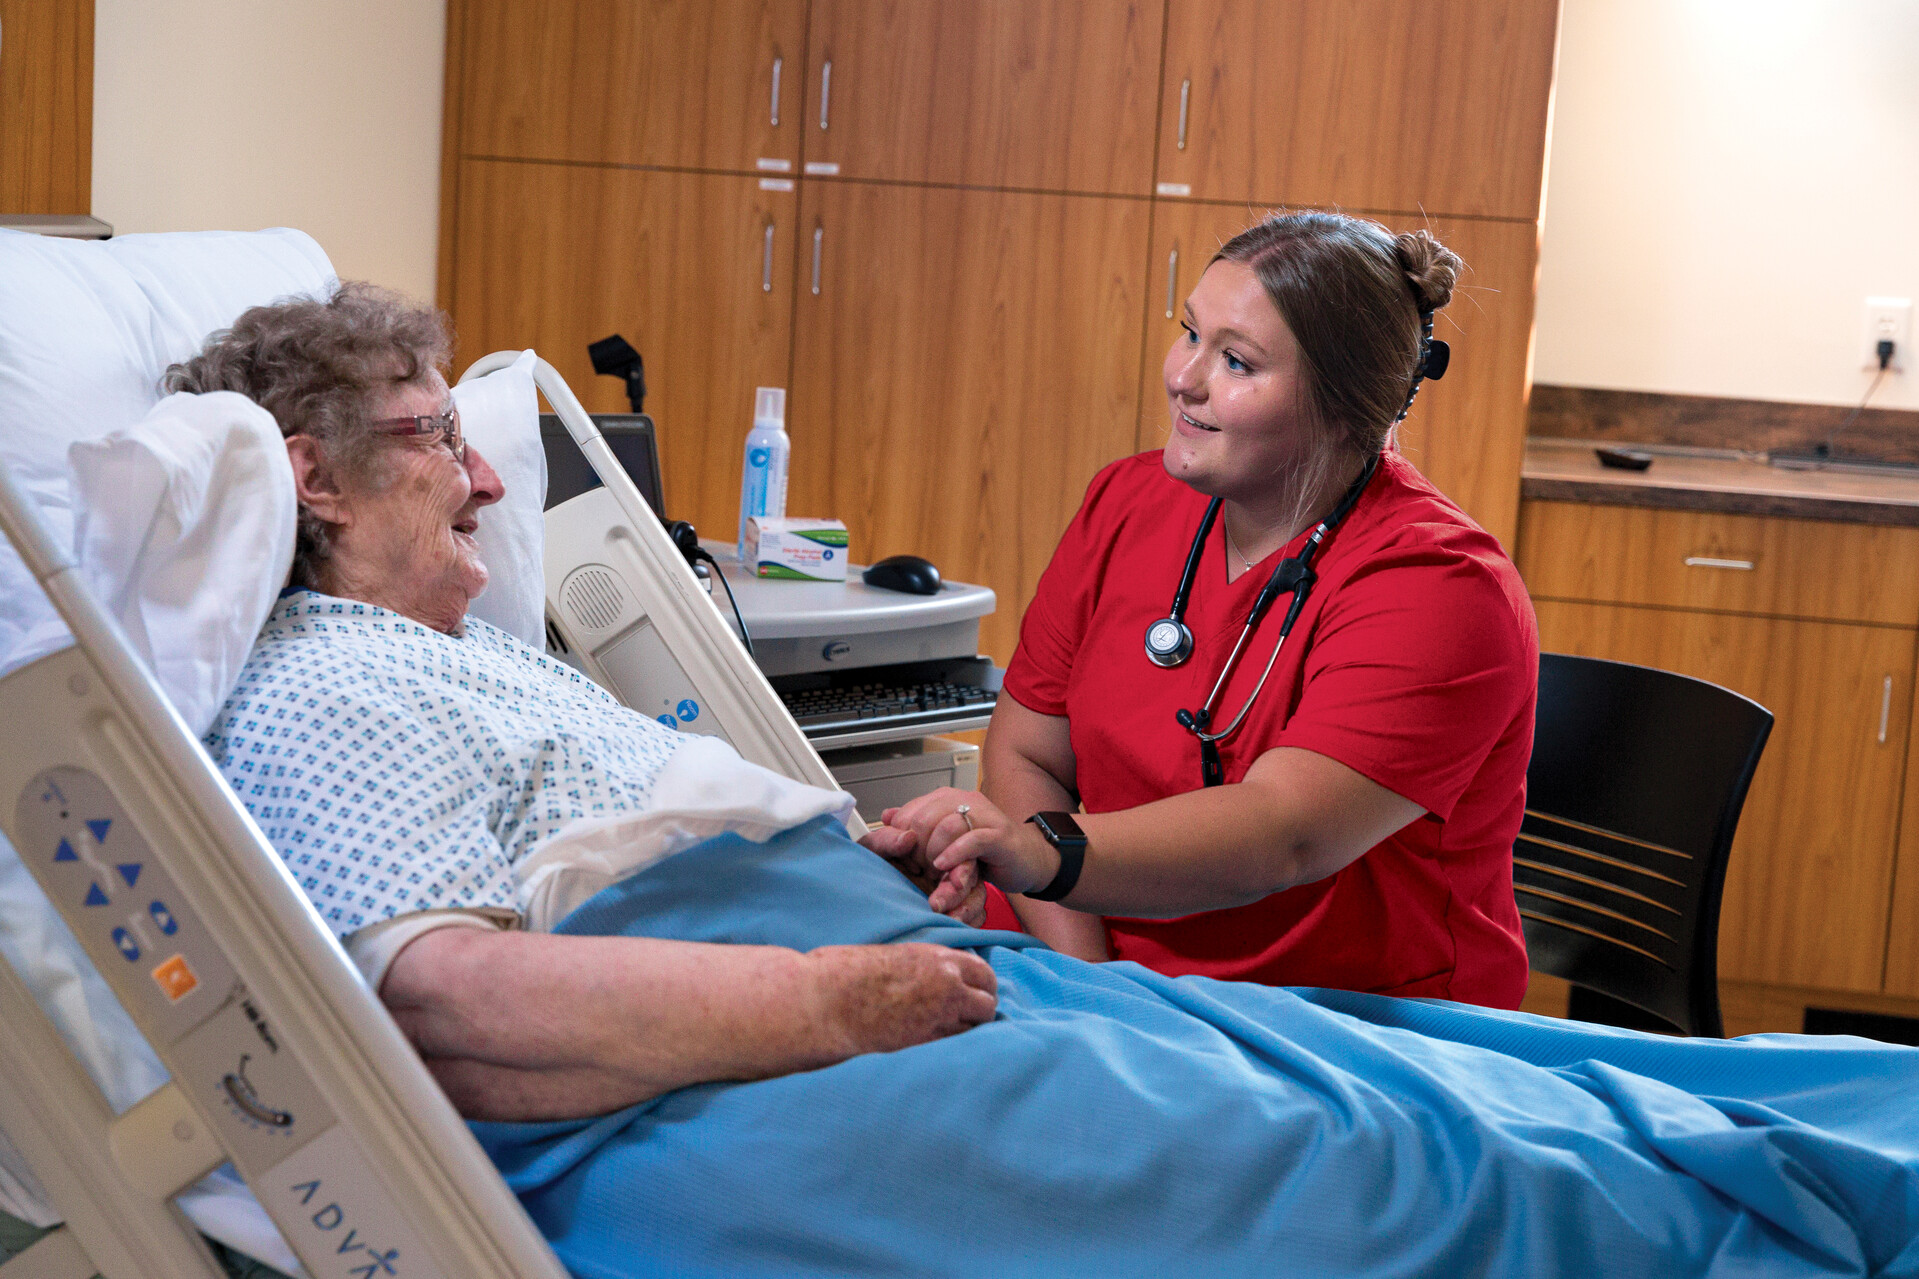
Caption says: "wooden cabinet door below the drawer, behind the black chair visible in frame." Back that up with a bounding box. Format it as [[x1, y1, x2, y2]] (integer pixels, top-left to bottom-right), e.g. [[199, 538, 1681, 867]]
[[1535, 599, 1913, 991]]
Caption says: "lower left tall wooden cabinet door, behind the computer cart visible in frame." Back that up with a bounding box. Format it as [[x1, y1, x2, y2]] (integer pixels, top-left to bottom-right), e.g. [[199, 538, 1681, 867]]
[[451, 159, 798, 538]]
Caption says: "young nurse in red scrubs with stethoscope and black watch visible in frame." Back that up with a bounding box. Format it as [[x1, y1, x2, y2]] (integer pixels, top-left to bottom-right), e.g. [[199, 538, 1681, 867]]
[[888, 213, 1539, 1008]]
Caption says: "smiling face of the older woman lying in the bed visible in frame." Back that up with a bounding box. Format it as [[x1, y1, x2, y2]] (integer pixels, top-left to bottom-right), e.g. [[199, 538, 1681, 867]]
[[288, 373, 503, 634]]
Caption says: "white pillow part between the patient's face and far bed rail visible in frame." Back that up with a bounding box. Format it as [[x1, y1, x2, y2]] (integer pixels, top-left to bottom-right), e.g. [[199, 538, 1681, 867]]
[[453, 351, 547, 649]]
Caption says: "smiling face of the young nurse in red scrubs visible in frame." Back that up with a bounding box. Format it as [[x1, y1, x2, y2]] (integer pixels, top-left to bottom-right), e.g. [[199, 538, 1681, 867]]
[[1165, 261, 1313, 509]]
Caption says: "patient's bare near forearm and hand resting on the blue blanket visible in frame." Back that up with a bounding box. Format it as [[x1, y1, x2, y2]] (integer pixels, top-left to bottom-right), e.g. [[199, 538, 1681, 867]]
[[380, 928, 996, 1120]]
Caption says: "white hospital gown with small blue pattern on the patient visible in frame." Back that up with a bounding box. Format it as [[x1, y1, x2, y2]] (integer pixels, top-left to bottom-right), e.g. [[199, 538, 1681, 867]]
[[205, 591, 685, 935]]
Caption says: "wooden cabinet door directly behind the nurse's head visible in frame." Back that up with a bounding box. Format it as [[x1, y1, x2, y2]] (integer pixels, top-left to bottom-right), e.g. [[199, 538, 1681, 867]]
[[1140, 200, 1537, 547]]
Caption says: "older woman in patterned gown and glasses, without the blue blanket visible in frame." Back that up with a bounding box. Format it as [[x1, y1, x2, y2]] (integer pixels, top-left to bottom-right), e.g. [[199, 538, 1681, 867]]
[[180, 284, 994, 1118]]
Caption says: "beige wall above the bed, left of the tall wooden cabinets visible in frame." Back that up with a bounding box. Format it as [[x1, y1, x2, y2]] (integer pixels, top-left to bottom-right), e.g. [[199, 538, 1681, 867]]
[[94, 0, 445, 302]]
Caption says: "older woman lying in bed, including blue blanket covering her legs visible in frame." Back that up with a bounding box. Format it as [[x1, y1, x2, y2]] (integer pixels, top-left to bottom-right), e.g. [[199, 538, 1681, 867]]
[[183, 286, 1919, 1275]]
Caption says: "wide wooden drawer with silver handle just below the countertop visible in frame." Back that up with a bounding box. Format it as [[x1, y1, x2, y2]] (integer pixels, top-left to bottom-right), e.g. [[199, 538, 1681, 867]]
[[1518, 501, 1919, 626]]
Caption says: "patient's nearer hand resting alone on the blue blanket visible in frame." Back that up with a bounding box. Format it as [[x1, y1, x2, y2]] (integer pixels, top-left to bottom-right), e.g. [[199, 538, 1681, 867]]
[[806, 941, 1000, 1060]]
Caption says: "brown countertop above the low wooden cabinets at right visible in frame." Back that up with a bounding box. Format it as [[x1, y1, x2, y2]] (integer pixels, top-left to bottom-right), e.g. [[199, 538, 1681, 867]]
[[1520, 436, 1919, 526]]
